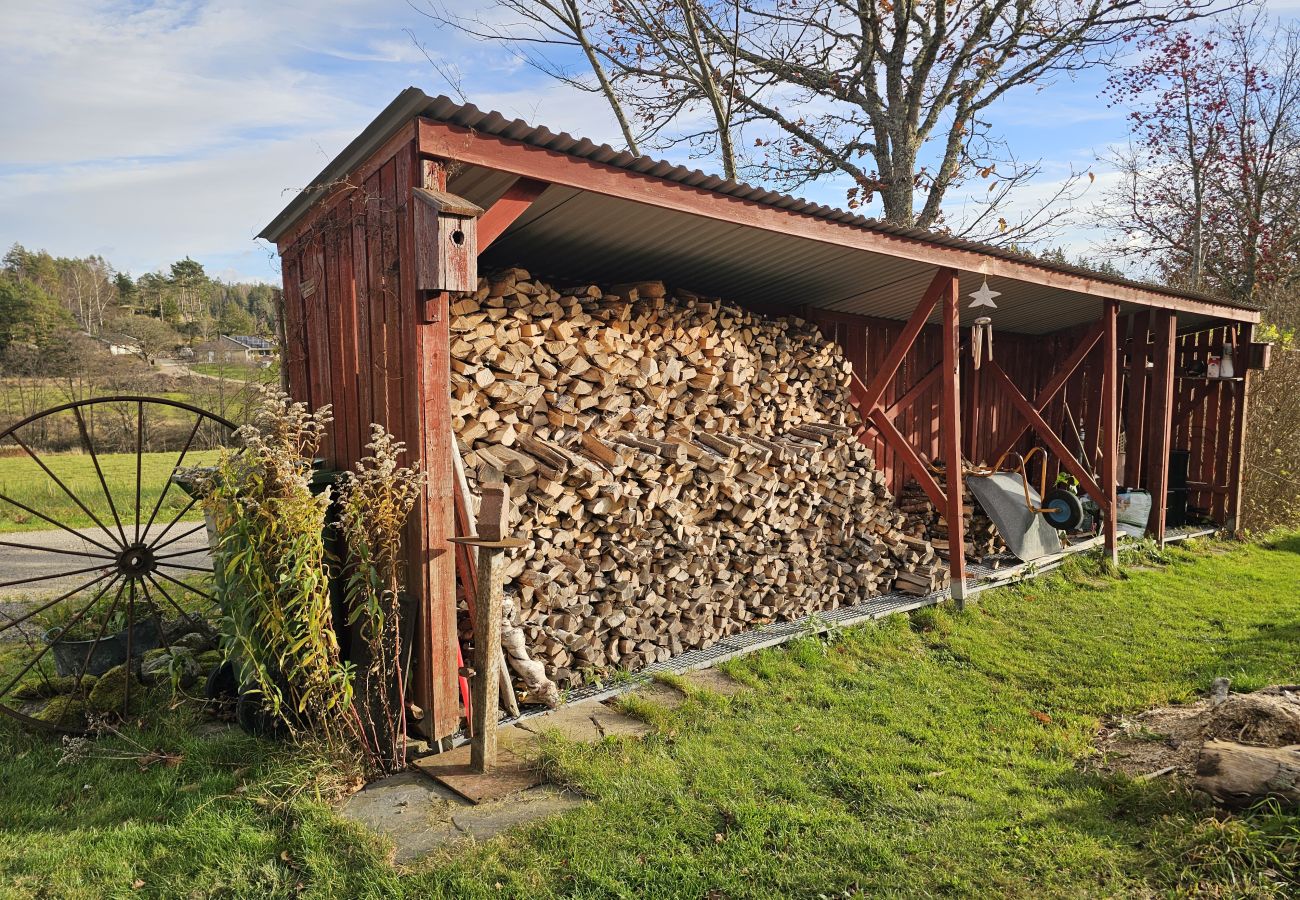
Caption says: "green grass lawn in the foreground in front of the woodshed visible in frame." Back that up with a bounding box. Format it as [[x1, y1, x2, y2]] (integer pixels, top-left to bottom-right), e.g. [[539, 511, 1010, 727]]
[[0, 536, 1300, 899]]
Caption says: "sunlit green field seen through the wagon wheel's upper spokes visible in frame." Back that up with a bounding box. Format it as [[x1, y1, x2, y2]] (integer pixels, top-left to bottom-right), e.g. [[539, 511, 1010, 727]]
[[0, 450, 220, 532]]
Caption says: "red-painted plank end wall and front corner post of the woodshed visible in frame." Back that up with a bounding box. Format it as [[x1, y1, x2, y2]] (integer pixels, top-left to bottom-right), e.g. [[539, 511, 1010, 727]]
[[271, 135, 462, 737]]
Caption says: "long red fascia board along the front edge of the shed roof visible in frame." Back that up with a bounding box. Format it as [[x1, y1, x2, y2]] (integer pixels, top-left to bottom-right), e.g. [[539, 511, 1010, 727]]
[[416, 117, 1260, 323]]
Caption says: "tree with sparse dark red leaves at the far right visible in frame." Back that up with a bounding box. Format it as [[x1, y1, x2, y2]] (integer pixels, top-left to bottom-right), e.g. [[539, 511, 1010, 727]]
[[1099, 12, 1300, 299]]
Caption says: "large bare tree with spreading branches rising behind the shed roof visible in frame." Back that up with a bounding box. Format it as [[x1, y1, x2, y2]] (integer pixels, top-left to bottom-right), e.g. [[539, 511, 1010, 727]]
[[430, 0, 1238, 241]]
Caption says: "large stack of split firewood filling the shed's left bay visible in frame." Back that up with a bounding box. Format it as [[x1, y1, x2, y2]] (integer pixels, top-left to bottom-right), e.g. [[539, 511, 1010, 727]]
[[451, 269, 935, 685]]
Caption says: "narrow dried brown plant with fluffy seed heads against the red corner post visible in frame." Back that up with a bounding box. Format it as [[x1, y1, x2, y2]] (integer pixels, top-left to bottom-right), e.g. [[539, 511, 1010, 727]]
[[338, 425, 424, 773]]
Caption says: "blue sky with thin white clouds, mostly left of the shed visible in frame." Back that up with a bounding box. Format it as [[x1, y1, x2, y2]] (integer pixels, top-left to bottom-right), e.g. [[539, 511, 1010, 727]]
[[0, 0, 1300, 281]]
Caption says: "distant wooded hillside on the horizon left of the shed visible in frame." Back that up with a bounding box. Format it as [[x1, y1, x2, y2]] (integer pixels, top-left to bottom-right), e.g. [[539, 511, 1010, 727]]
[[0, 243, 280, 364]]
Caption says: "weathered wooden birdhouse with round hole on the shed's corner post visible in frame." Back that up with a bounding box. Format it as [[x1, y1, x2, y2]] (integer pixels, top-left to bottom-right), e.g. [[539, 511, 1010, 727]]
[[415, 187, 484, 293]]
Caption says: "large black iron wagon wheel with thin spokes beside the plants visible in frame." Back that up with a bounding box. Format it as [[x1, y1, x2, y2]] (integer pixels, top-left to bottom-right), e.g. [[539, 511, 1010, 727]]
[[0, 395, 238, 734]]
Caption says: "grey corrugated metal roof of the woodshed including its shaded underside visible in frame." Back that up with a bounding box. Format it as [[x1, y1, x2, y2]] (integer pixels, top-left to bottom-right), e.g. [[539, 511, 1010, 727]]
[[261, 88, 1249, 334]]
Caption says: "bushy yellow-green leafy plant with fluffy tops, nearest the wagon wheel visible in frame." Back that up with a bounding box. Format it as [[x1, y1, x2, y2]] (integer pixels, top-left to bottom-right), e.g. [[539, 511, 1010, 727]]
[[203, 391, 356, 747]]
